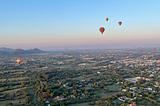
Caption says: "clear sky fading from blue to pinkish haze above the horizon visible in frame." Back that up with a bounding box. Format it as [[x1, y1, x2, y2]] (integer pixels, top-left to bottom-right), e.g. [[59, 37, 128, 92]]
[[0, 0, 160, 50]]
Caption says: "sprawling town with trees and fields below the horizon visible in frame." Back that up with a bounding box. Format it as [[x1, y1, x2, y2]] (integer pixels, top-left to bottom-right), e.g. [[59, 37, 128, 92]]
[[0, 48, 160, 106]]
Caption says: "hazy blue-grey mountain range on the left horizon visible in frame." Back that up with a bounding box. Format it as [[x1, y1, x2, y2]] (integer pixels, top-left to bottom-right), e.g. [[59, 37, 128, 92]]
[[0, 47, 46, 55]]
